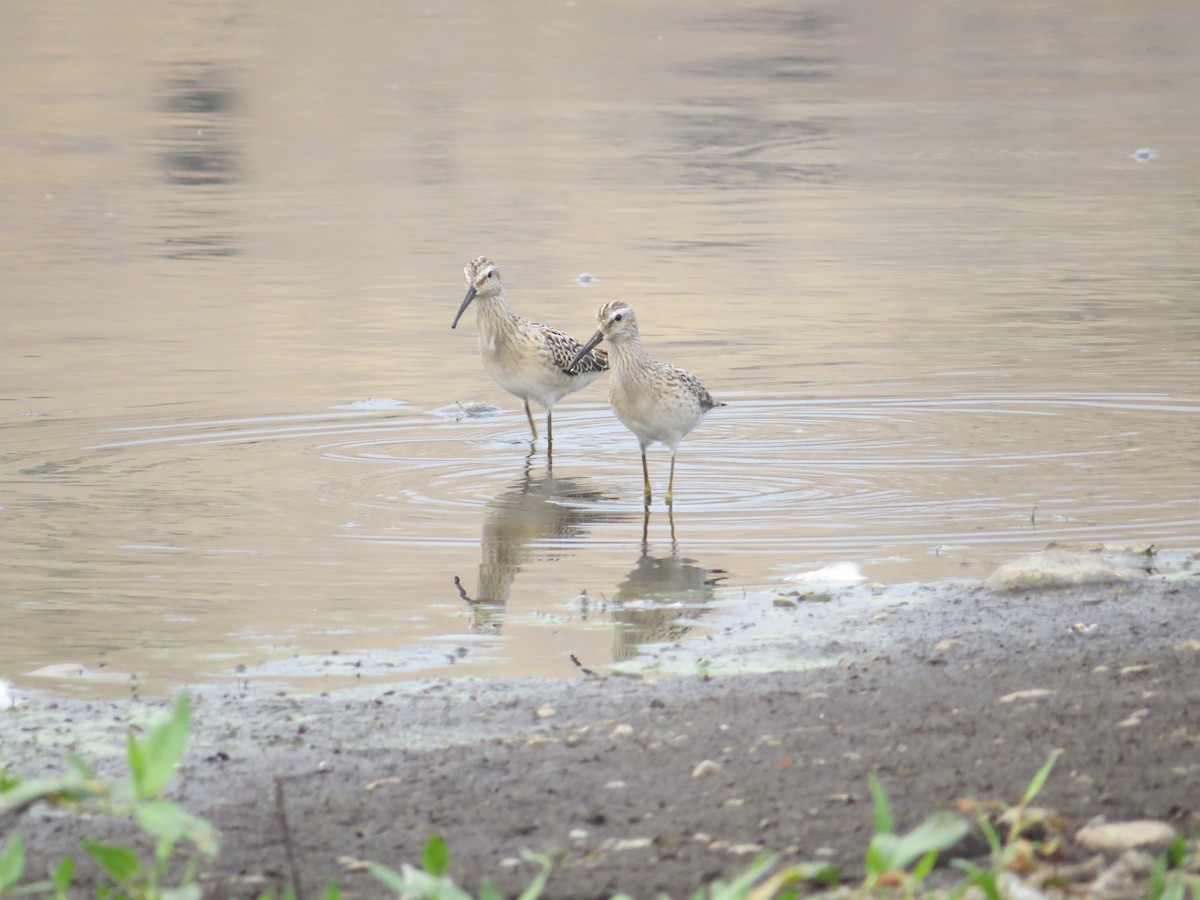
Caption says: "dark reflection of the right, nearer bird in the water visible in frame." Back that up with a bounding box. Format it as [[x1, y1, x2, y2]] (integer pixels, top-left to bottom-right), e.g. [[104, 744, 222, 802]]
[[612, 506, 728, 660]]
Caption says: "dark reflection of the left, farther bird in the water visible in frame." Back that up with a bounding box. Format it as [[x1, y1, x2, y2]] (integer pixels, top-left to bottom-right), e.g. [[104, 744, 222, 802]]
[[454, 451, 628, 631]]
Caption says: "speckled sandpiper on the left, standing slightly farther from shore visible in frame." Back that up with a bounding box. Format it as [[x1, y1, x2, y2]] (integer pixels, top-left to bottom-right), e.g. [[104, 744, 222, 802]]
[[450, 257, 608, 449]]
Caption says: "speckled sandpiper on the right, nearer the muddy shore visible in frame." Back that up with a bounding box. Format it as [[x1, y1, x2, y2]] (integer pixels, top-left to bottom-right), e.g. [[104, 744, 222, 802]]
[[570, 300, 725, 506]]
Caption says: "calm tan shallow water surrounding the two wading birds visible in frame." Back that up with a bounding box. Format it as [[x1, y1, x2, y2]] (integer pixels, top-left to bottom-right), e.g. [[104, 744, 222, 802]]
[[0, 0, 1200, 694]]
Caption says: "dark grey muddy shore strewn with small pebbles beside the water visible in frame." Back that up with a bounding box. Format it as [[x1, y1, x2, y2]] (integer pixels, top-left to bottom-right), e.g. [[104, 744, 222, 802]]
[[0, 576, 1200, 898]]
